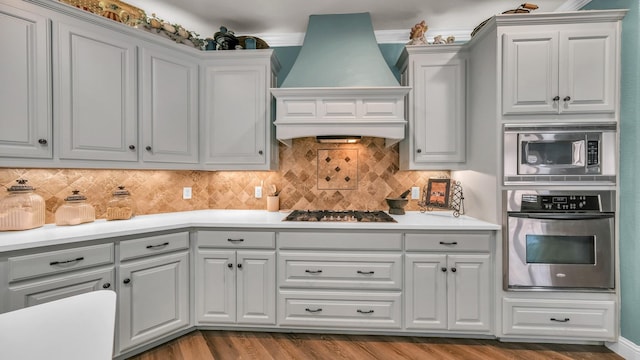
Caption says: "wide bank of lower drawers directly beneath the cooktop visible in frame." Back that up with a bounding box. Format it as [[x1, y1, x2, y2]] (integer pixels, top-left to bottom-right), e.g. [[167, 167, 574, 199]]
[[278, 232, 402, 330]]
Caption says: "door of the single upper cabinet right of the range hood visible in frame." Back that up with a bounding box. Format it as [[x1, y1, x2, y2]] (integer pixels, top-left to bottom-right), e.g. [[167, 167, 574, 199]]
[[413, 54, 466, 165]]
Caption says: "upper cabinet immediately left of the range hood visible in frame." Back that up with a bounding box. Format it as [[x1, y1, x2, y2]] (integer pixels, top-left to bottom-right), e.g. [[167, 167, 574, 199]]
[[200, 50, 277, 170]]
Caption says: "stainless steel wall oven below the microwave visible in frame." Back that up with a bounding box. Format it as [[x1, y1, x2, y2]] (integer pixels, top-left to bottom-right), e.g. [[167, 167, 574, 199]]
[[504, 190, 615, 291]]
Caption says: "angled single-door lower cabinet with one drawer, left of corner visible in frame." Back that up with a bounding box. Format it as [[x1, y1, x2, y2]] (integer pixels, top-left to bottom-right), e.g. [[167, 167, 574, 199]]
[[118, 232, 190, 352]]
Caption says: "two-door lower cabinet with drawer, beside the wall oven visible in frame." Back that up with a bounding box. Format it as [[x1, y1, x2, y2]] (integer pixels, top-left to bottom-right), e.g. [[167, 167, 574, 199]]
[[404, 233, 493, 334]]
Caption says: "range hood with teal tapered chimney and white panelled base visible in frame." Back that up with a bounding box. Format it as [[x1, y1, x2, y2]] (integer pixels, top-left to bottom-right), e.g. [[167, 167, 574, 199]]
[[271, 13, 409, 146]]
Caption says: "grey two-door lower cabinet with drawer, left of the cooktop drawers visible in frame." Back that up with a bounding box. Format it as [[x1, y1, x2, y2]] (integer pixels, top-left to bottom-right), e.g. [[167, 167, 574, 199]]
[[195, 231, 276, 325]]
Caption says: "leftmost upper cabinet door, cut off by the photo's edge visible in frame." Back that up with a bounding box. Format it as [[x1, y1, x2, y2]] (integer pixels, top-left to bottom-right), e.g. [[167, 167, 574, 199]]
[[0, 4, 52, 158]]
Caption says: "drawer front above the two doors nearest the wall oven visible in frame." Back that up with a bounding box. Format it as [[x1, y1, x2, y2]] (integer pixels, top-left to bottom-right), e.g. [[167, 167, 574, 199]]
[[405, 232, 491, 252]]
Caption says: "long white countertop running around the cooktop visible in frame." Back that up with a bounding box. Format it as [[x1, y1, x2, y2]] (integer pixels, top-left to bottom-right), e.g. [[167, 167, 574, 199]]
[[0, 210, 500, 252]]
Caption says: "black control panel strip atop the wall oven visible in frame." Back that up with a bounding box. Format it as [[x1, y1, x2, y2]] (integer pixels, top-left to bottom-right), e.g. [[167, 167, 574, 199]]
[[520, 194, 600, 212]]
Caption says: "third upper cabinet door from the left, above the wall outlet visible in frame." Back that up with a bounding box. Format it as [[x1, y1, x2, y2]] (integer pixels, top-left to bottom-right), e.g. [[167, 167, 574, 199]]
[[141, 47, 198, 163]]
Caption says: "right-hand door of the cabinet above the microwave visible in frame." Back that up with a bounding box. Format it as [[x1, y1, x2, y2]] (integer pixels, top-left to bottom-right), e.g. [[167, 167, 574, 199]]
[[559, 24, 617, 112]]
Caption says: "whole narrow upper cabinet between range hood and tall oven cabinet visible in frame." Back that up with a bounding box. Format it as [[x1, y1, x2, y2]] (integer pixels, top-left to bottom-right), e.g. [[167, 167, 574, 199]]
[[399, 45, 467, 170]]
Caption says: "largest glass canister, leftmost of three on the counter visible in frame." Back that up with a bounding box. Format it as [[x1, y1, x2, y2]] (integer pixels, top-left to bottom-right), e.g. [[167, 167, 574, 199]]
[[0, 179, 45, 231]]
